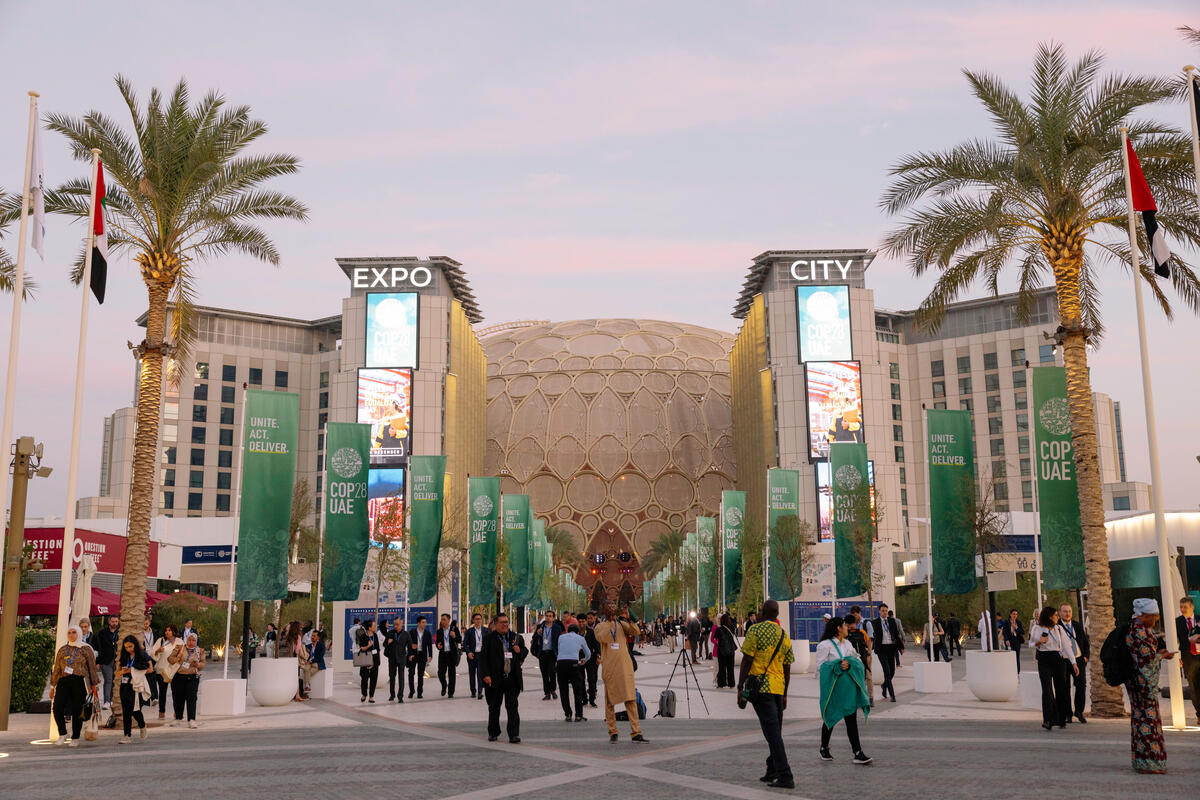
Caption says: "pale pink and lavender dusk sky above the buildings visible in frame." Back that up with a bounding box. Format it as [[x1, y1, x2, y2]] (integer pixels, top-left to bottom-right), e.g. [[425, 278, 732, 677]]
[[0, 0, 1200, 517]]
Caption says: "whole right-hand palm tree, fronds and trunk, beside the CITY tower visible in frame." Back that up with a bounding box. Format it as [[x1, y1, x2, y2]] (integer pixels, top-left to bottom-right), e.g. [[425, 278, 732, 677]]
[[881, 44, 1200, 716]]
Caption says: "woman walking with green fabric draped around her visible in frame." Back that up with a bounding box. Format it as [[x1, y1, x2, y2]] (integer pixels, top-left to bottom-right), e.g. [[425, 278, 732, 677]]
[[816, 616, 871, 764]]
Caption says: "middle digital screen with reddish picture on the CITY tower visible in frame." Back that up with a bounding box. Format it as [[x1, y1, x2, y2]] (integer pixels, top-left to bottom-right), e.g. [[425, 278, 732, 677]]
[[804, 361, 866, 459]]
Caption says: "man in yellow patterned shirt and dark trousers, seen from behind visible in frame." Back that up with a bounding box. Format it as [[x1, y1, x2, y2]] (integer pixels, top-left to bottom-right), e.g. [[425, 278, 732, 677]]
[[738, 600, 796, 789]]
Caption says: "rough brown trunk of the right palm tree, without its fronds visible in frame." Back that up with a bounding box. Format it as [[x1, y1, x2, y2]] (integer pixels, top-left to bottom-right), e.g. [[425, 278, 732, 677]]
[[1051, 256, 1124, 718]]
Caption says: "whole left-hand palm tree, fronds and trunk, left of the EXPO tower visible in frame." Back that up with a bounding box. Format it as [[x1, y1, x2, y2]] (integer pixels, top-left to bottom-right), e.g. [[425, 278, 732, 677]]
[[47, 76, 307, 633]]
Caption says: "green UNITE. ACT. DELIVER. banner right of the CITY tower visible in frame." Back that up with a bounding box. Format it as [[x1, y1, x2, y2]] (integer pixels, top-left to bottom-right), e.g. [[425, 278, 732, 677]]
[[925, 409, 978, 595]]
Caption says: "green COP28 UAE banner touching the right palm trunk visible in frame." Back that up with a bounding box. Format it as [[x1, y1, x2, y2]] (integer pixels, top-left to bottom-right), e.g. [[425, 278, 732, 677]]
[[1033, 367, 1086, 589]]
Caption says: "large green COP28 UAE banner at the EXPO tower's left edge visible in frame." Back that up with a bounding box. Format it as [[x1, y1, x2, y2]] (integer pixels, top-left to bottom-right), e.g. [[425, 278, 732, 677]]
[[320, 422, 371, 602]]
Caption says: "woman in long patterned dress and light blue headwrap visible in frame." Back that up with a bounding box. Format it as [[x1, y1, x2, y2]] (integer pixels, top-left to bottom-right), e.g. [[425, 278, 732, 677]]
[[1126, 597, 1175, 775]]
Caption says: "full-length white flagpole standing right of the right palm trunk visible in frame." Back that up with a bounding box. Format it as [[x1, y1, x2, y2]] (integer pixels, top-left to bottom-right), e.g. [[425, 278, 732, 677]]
[[1121, 125, 1195, 729]]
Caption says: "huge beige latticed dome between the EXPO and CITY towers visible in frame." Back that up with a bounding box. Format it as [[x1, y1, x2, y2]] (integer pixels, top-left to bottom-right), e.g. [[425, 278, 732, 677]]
[[481, 319, 737, 599]]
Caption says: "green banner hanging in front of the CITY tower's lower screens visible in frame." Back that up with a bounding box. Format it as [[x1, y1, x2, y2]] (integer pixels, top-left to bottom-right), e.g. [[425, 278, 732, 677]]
[[829, 441, 875, 597]]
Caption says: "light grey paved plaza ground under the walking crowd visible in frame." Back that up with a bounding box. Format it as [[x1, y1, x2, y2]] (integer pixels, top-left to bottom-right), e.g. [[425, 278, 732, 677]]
[[0, 648, 1200, 800]]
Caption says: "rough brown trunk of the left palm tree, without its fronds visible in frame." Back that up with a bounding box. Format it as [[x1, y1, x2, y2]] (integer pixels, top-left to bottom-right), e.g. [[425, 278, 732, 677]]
[[121, 282, 170, 636]]
